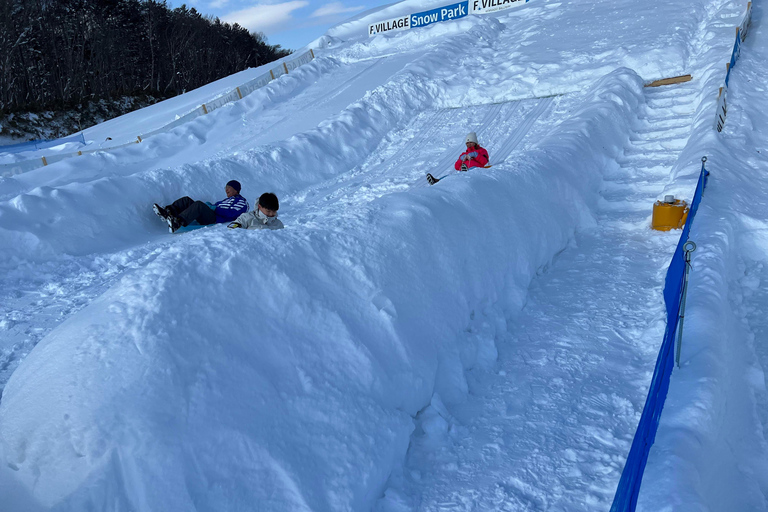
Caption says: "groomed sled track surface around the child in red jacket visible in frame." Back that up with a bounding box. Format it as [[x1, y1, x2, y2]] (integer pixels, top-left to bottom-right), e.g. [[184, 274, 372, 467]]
[[291, 98, 562, 207]]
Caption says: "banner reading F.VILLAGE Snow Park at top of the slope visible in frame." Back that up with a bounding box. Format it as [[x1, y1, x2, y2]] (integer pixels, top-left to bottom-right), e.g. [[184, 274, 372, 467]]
[[368, 0, 528, 37]]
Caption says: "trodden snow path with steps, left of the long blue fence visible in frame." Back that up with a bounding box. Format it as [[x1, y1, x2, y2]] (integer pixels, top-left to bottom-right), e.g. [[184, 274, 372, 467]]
[[381, 82, 699, 512]]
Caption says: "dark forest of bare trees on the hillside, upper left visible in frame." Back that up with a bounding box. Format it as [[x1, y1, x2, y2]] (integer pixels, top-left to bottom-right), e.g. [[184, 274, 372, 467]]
[[0, 0, 289, 113]]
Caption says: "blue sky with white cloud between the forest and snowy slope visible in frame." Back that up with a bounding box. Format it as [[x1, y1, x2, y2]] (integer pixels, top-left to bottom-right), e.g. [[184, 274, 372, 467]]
[[180, 0, 384, 49]]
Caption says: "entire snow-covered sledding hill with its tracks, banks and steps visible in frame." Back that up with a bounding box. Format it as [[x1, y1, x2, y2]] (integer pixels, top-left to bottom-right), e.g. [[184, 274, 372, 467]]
[[0, 0, 768, 506]]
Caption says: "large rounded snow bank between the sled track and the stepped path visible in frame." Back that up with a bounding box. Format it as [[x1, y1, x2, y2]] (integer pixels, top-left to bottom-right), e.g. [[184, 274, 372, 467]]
[[0, 70, 642, 510]]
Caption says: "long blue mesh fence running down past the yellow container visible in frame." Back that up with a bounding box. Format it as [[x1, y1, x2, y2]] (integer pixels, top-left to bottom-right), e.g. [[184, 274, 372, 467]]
[[611, 158, 709, 512]]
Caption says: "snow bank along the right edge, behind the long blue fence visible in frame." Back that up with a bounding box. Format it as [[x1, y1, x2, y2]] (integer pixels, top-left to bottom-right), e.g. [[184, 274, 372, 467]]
[[638, 3, 768, 512]]
